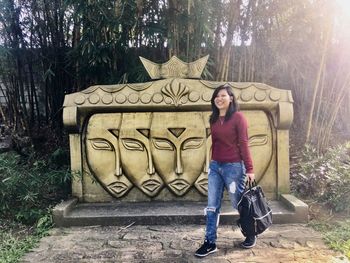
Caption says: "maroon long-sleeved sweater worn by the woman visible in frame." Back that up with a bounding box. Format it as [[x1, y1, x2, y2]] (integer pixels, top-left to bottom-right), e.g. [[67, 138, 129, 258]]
[[210, 112, 253, 173]]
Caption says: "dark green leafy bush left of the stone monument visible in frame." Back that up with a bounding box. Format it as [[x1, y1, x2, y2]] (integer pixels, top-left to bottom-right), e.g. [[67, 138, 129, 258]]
[[0, 149, 70, 224]]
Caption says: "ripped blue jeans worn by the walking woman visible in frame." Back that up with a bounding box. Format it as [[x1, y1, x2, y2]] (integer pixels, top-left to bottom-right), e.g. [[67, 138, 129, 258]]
[[205, 160, 245, 243]]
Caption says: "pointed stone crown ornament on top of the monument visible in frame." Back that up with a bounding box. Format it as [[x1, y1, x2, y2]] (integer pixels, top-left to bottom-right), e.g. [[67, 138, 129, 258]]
[[140, 55, 209, 79]]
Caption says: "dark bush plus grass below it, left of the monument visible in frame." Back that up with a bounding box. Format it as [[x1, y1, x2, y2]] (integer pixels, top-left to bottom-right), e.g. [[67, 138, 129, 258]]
[[0, 148, 67, 263]]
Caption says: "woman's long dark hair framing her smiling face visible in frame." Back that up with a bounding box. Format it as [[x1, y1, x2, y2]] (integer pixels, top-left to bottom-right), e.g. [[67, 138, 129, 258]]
[[209, 85, 239, 124]]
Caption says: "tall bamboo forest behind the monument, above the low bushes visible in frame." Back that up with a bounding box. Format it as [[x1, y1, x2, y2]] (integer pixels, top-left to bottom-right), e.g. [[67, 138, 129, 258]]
[[0, 0, 350, 152]]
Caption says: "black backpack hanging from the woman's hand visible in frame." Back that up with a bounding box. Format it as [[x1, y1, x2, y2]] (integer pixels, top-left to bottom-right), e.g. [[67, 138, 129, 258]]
[[237, 181, 272, 237]]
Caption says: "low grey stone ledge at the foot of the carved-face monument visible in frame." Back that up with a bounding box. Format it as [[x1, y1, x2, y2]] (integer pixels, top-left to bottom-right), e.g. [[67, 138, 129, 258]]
[[53, 194, 308, 227]]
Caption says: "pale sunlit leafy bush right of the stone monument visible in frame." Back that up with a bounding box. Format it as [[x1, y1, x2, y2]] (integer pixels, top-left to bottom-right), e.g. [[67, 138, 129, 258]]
[[291, 142, 350, 213]]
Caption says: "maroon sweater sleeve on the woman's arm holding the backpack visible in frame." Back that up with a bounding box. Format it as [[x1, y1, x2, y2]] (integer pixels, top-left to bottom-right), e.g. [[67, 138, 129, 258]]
[[236, 112, 254, 173]]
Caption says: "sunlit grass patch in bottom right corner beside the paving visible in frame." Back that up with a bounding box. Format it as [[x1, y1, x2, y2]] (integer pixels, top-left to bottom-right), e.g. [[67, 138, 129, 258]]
[[310, 220, 350, 259]]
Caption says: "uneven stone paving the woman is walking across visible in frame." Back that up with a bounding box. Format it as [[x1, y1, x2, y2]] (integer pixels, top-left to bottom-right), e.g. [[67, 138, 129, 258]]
[[22, 224, 349, 263]]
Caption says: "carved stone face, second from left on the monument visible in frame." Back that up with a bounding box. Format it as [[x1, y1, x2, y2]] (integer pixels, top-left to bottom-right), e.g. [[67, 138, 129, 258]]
[[119, 113, 164, 197]]
